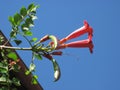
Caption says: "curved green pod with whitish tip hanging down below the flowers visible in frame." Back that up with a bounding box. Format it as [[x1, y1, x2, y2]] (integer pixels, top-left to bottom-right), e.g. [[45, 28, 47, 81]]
[[52, 59, 61, 82]]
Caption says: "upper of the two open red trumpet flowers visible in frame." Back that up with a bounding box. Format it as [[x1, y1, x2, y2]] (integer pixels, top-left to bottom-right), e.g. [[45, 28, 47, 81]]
[[59, 21, 93, 44]]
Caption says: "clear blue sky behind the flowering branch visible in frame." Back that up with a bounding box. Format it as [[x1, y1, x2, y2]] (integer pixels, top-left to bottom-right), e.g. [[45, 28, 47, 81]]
[[0, 0, 120, 90]]
